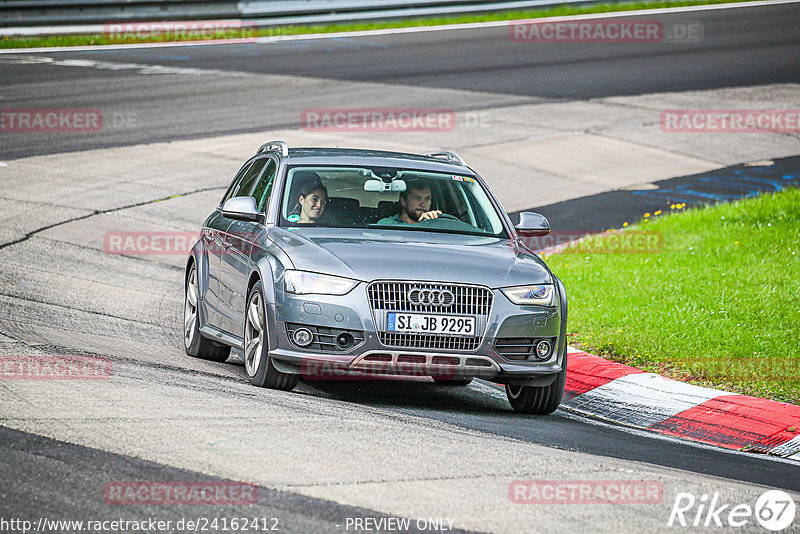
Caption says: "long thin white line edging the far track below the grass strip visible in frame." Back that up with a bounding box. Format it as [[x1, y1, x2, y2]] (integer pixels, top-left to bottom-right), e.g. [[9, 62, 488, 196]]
[[0, 0, 800, 54]]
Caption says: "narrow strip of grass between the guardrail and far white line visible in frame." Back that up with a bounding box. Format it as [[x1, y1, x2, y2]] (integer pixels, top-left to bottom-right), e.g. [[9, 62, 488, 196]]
[[0, 0, 749, 48]]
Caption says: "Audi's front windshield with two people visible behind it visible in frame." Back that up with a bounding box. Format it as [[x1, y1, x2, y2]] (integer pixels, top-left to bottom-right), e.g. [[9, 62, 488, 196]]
[[280, 166, 506, 237]]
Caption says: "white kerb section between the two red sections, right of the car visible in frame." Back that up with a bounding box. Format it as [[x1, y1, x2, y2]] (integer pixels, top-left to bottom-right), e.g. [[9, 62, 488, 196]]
[[565, 373, 731, 428]]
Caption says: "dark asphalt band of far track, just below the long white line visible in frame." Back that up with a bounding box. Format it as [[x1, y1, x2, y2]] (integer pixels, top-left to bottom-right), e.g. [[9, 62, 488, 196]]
[[0, 4, 800, 158]]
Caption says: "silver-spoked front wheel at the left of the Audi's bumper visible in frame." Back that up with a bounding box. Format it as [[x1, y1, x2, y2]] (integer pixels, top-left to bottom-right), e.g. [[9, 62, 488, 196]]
[[244, 280, 300, 391]]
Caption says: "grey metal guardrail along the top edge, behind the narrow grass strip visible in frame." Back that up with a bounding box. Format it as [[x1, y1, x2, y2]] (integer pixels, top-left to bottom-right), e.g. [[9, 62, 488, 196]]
[[0, 0, 614, 35]]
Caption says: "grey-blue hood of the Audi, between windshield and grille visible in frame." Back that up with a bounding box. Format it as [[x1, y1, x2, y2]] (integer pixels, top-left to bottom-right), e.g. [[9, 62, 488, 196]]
[[270, 227, 552, 288]]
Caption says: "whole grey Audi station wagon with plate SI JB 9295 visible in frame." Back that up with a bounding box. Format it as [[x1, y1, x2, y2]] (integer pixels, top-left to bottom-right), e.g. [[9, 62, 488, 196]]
[[184, 141, 567, 414]]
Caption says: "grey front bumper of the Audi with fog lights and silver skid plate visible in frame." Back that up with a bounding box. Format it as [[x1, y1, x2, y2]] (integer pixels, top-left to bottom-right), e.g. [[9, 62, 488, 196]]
[[267, 283, 566, 382]]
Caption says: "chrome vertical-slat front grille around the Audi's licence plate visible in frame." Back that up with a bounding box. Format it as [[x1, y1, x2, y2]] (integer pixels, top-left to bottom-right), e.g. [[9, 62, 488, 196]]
[[367, 282, 494, 351]]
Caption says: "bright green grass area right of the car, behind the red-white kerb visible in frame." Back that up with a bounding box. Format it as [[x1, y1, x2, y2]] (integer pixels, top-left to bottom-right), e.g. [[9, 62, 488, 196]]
[[547, 189, 800, 404]]
